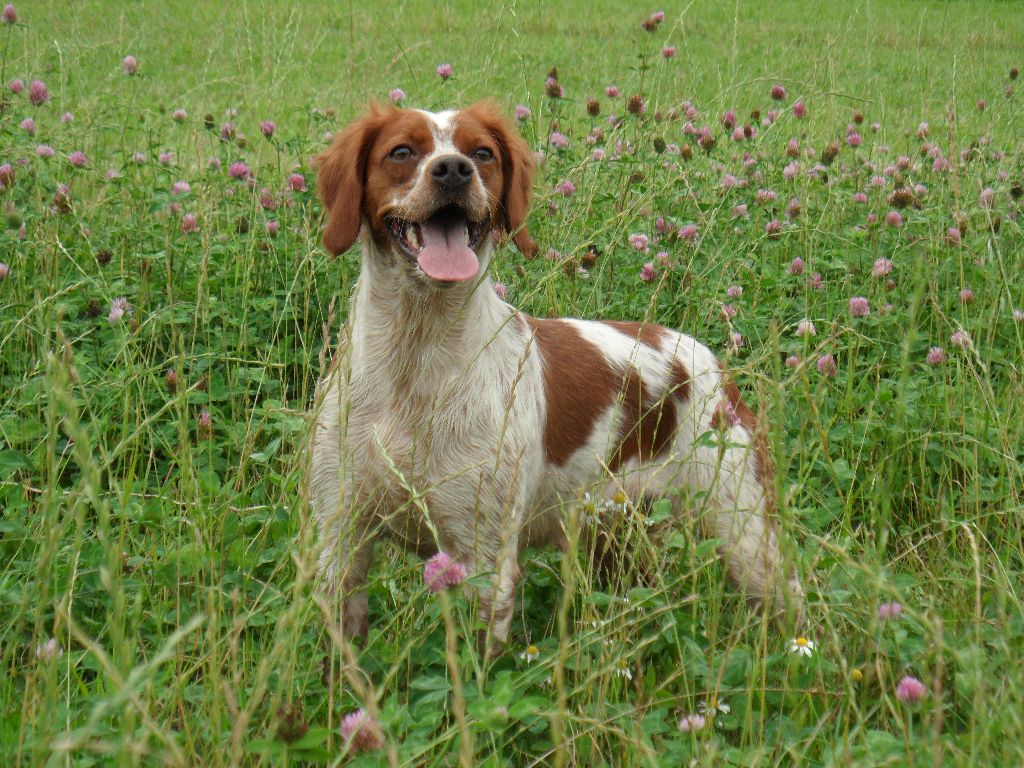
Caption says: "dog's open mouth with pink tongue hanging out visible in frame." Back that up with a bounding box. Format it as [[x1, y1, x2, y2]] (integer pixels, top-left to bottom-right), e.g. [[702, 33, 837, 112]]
[[387, 206, 484, 283]]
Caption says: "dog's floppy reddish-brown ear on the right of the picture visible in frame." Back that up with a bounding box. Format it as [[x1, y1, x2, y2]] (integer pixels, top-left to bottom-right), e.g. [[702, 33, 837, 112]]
[[468, 101, 537, 259]]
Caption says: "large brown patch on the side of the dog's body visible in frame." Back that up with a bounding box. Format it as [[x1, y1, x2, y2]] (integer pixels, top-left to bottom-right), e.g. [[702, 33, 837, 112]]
[[527, 317, 690, 470]]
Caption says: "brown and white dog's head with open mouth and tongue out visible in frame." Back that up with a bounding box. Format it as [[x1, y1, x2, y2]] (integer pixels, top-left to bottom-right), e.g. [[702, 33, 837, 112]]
[[316, 102, 537, 284]]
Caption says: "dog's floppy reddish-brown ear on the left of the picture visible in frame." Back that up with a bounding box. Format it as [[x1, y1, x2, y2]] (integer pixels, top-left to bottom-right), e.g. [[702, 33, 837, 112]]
[[316, 104, 381, 256]]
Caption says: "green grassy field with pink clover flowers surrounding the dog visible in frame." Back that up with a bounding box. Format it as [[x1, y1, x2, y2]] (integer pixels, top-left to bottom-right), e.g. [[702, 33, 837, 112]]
[[0, 0, 1024, 766]]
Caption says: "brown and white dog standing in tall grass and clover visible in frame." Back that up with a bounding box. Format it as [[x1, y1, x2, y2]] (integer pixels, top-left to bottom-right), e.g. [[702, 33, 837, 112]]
[[309, 102, 803, 643]]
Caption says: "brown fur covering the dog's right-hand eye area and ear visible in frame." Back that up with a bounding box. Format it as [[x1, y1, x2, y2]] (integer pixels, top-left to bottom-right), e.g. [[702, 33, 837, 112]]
[[454, 101, 537, 259]]
